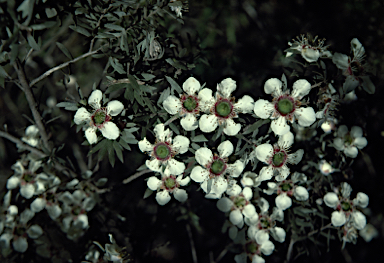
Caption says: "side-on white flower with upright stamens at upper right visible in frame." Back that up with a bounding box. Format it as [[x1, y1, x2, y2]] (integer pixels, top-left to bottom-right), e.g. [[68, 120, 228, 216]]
[[285, 35, 332, 62]]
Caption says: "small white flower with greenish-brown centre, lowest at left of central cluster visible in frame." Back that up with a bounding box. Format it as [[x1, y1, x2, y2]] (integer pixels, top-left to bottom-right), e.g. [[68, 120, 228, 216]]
[[147, 169, 190, 205]]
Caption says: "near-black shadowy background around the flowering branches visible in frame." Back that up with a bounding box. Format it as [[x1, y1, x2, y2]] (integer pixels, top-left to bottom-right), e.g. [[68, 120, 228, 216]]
[[0, 0, 384, 262]]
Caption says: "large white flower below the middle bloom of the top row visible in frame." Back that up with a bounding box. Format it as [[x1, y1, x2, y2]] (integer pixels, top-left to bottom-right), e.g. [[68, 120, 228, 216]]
[[191, 141, 244, 198]]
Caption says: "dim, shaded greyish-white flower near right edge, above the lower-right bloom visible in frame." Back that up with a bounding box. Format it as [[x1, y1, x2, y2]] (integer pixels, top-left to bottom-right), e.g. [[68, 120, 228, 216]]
[[333, 125, 368, 158]]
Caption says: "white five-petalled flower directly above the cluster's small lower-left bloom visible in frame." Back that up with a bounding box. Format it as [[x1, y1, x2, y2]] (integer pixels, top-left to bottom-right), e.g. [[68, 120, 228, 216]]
[[139, 123, 189, 175]]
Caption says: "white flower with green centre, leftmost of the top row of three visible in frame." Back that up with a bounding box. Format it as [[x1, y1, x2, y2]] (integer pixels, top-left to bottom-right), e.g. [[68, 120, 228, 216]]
[[163, 77, 212, 131]]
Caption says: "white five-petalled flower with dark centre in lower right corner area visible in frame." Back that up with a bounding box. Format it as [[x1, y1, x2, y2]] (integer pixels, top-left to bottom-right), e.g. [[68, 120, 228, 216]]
[[324, 182, 369, 230]]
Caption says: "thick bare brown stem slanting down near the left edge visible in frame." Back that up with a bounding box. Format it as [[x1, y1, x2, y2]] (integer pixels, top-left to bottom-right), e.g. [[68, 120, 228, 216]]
[[13, 61, 51, 151]]
